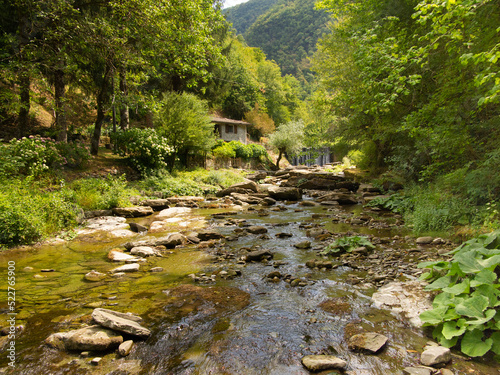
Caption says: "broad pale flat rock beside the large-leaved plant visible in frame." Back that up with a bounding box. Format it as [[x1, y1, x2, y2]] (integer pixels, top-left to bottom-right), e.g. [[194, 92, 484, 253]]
[[372, 280, 432, 328]]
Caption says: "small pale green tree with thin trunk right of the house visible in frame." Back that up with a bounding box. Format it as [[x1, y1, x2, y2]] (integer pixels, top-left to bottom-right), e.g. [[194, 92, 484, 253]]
[[269, 121, 304, 168]]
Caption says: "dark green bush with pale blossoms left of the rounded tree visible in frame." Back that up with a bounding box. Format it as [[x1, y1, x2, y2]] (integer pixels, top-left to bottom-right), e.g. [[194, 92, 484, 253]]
[[112, 129, 173, 176]]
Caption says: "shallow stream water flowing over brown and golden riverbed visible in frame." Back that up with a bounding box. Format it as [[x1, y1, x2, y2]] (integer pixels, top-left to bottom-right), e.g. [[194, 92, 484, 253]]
[[0, 201, 499, 375]]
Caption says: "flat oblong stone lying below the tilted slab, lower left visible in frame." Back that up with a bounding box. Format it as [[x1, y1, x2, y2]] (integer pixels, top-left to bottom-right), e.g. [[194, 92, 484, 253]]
[[45, 325, 123, 351]]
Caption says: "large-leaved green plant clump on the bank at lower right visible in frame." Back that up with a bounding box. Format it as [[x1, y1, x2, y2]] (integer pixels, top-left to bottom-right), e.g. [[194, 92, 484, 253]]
[[419, 230, 500, 357]]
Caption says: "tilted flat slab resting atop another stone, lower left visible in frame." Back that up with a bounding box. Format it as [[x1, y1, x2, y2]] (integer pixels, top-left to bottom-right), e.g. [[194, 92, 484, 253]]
[[92, 308, 151, 337]]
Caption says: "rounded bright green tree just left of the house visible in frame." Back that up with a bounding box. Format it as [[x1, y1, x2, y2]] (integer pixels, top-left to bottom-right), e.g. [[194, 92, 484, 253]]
[[154, 92, 215, 171]]
